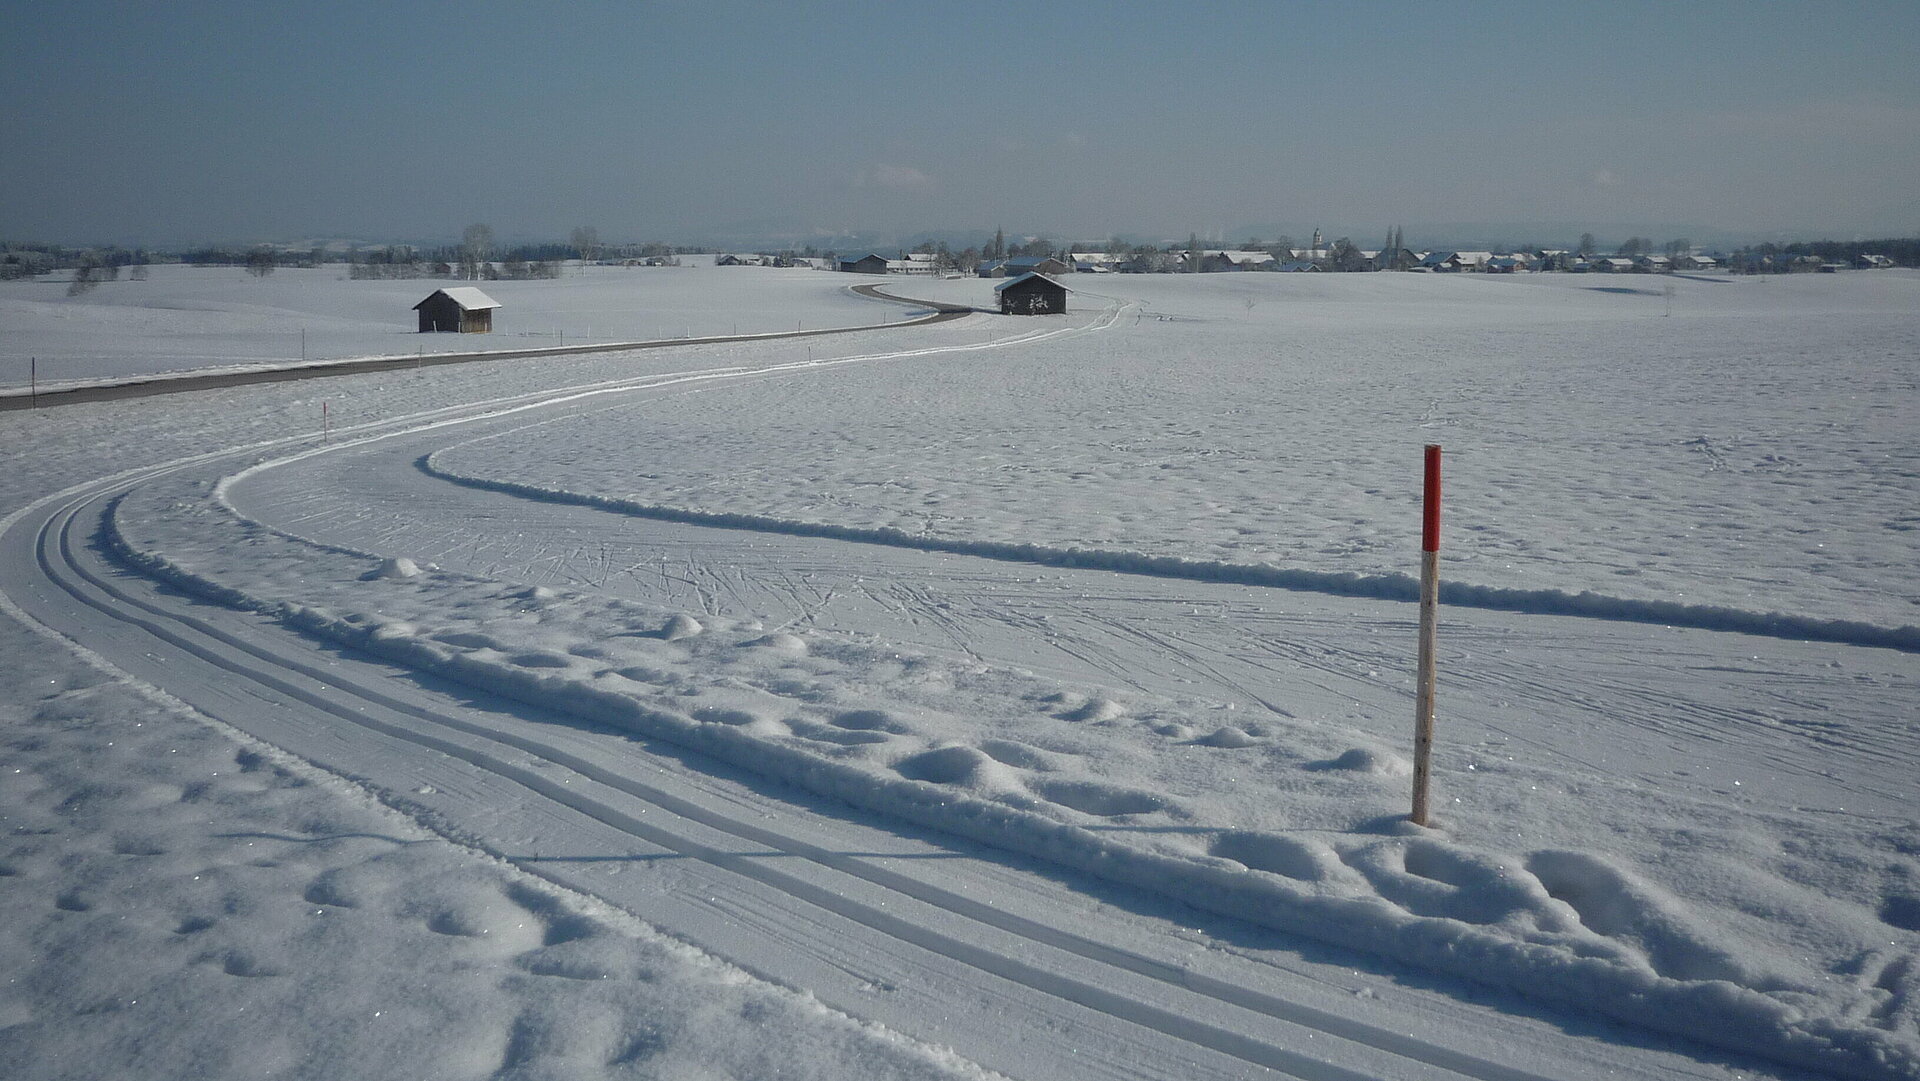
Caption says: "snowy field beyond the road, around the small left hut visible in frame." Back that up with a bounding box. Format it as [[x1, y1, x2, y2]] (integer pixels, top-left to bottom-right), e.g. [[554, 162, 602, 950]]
[[0, 255, 900, 390]]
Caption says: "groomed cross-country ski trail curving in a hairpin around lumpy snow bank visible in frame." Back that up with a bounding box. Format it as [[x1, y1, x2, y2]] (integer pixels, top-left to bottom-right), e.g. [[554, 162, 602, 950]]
[[0, 291, 1910, 1081]]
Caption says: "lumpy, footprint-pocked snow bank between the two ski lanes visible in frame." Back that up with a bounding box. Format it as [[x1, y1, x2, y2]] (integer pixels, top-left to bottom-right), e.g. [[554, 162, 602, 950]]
[[104, 472, 1920, 1079]]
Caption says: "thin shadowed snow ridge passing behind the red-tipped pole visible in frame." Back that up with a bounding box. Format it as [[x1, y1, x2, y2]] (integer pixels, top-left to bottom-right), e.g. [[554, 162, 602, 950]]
[[415, 451, 1920, 653]]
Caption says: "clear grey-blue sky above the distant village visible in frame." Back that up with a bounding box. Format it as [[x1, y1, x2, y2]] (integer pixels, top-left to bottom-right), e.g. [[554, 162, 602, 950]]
[[0, 0, 1920, 246]]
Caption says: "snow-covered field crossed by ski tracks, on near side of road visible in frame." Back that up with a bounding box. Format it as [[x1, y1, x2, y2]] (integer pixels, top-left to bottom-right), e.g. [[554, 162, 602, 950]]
[[0, 269, 1920, 1077]]
